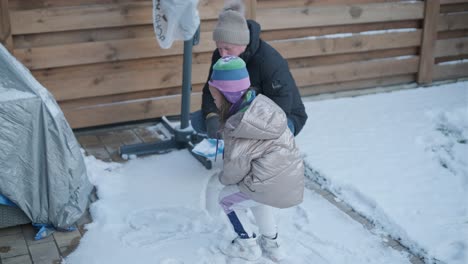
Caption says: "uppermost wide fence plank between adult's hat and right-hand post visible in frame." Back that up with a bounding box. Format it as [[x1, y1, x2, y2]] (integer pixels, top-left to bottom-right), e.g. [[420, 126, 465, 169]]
[[257, 2, 424, 30]]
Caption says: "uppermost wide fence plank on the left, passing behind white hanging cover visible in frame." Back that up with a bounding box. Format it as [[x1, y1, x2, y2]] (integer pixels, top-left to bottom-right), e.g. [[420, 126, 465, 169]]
[[11, 0, 222, 35]]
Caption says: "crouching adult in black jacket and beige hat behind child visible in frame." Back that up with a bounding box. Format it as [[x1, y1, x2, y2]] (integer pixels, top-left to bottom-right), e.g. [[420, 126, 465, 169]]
[[192, 1, 307, 137]]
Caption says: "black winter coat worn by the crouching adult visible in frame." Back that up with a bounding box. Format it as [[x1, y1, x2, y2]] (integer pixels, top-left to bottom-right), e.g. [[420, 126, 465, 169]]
[[202, 20, 307, 135]]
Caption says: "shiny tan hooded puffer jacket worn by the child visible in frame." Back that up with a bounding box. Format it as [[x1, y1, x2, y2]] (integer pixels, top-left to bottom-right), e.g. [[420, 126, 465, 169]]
[[219, 94, 304, 208]]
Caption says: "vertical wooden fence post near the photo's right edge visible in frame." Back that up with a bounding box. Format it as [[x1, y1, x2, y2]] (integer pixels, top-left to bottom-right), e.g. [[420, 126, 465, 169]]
[[418, 0, 440, 84]]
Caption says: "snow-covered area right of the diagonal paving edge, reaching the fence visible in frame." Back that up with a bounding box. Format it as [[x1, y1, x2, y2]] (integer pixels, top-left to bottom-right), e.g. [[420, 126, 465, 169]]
[[298, 82, 468, 264]]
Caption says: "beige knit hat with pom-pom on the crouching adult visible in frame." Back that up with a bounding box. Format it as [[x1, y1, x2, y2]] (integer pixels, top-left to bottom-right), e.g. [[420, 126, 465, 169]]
[[213, 1, 250, 45]]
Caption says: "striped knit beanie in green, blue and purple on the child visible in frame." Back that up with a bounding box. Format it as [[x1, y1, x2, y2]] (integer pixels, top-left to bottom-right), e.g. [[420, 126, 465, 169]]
[[208, 56, 250, 104]]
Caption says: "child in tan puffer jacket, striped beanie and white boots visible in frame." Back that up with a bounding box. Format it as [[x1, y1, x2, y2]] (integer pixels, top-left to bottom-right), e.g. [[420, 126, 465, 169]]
[[209, 56, 304, 261]]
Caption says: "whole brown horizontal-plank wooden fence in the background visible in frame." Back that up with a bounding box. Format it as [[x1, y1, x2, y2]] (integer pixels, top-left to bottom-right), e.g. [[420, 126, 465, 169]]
[[0, 0, 468, 128]]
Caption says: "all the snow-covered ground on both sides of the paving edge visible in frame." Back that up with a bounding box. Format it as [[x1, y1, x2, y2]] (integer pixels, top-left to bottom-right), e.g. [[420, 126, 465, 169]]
[[64, 82, 468, 264]]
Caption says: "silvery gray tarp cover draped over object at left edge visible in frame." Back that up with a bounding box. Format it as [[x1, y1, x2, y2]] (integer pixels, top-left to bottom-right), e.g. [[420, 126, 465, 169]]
[[0, 44, 93, 228]]
